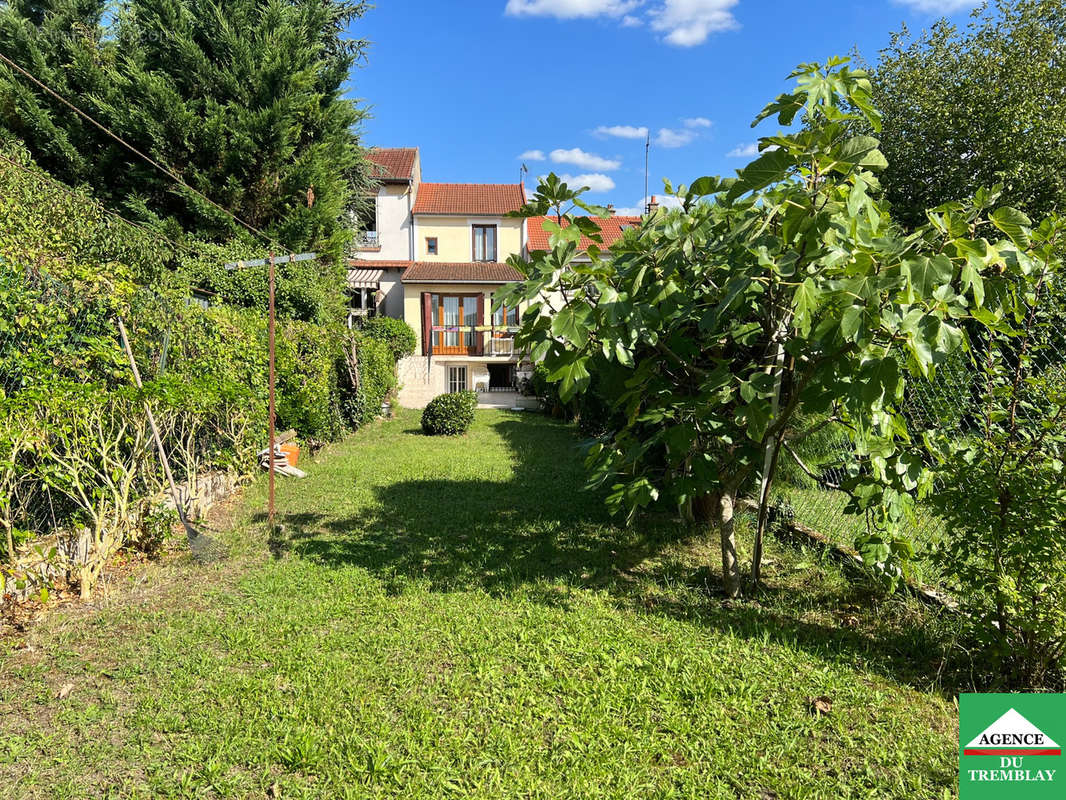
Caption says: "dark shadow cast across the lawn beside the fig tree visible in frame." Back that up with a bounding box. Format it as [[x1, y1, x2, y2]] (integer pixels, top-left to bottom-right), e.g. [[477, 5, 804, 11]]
[[264, 419, 959, 689]]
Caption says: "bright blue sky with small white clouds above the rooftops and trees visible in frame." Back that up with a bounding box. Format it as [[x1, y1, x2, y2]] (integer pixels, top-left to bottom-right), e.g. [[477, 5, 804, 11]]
[[351, 0, 976, 209]]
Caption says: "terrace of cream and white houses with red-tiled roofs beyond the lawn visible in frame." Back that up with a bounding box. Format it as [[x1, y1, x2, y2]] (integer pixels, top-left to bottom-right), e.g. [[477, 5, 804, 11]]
[[349, 147, 641, 407]]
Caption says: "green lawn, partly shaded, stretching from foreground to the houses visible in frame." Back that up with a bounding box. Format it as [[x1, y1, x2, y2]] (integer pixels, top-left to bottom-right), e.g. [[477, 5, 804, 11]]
[[0, 411, 957, 800]]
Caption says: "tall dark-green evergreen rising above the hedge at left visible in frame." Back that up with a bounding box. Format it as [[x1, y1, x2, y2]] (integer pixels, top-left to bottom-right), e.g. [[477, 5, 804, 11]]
[[0, 0, 375, 256]]
